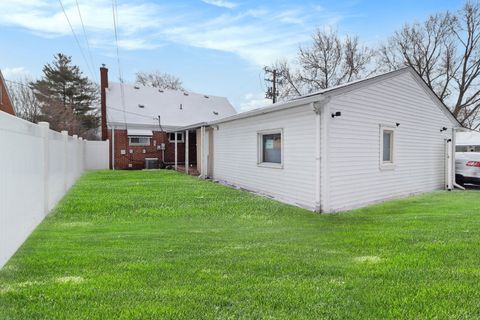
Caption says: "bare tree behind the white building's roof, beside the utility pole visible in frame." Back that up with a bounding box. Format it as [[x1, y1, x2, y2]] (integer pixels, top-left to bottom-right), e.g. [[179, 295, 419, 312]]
[[272, 29, 375, 100]]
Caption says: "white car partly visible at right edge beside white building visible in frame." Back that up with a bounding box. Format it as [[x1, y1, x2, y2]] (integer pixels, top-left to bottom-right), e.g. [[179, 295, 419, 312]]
[[455, 152, 480, 185]]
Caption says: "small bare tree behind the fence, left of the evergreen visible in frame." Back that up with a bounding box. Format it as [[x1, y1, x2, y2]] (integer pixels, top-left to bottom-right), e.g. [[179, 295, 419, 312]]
[[8, 78, 41, 123]]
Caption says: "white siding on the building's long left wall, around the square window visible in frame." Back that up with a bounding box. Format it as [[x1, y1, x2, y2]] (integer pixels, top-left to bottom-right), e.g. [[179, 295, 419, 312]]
[[213, 105, 316, 209]]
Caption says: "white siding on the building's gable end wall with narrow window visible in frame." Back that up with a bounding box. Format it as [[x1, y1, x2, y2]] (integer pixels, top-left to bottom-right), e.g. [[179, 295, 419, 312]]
[[326, 73, 452, 211]]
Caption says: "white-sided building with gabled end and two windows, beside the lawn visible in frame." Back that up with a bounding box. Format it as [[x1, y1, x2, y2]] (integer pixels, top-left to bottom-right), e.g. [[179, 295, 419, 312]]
[[175, 68, 461, 212]]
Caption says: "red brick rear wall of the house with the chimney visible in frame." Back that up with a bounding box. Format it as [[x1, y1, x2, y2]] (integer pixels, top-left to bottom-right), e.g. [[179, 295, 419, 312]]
[[108, 129, 197, 169]]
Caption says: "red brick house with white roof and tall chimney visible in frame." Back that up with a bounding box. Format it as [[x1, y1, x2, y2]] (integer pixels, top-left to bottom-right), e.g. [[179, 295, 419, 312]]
[[100, 67, 236, 171]]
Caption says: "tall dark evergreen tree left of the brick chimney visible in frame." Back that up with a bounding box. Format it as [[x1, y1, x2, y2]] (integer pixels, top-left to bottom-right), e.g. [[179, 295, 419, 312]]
[[30, 53, 99, 139]]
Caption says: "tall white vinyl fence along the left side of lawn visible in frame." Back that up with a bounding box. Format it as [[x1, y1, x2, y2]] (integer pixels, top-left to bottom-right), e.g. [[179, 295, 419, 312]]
[[0, 111, 109, 268]]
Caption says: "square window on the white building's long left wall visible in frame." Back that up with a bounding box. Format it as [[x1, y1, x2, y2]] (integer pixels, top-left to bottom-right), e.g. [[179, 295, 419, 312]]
[[258, 130, 283, 167]]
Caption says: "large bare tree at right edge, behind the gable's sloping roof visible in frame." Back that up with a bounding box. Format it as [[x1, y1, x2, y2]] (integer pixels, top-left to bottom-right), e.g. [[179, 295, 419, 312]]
[[379, 2, 480, 127]]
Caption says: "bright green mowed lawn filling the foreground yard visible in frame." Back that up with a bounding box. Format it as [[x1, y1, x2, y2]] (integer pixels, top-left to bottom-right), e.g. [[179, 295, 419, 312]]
[[0, 171, 480, 320]]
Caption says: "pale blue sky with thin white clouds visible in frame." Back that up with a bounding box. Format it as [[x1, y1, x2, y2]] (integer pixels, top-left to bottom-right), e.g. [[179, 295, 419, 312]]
[[0, 0, 463, 111]]
